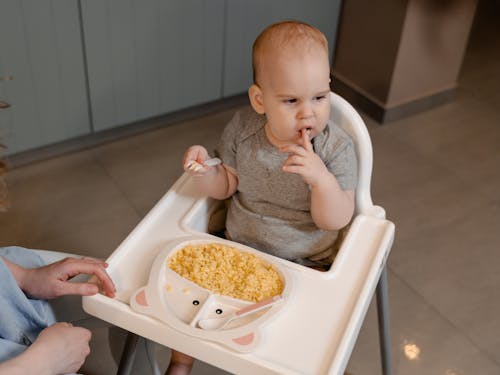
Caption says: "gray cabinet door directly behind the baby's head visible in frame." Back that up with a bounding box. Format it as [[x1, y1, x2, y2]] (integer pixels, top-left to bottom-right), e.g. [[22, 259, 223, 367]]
[[223, 0, 341, 97]]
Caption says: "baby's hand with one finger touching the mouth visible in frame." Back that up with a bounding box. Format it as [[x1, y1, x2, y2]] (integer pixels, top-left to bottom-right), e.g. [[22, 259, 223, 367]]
[[280, 130, 330, 187]]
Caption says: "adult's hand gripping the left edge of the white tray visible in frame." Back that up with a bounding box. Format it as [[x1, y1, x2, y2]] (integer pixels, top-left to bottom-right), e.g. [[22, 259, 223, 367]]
[[20, 258, 115, 299]]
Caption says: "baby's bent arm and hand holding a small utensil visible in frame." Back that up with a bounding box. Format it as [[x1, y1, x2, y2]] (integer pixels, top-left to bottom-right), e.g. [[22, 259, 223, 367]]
[[183, 145, 238, 200]]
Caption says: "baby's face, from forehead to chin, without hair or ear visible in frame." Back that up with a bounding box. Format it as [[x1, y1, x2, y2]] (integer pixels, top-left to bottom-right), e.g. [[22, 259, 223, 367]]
[[259, 49, 330, 147]]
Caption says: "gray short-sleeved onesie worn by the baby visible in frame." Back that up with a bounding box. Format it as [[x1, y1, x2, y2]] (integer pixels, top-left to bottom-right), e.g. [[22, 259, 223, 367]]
[[216, 110, 357, 261]]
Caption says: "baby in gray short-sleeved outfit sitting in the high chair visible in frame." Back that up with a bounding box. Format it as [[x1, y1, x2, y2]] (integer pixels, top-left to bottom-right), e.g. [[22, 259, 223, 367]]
[[171, 21, 357, 375]]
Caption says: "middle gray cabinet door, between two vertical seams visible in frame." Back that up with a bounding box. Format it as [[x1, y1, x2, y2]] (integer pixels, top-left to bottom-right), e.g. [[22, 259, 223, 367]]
[[82, 0, 224, 130]]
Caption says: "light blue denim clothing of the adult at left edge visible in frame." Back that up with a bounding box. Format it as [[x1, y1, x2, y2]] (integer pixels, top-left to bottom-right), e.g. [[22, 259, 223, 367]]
[[0, 246, 55, 362]]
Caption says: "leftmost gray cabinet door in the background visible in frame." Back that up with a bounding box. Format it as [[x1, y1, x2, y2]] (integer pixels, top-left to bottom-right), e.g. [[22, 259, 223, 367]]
[[0, 0, 90, 154]]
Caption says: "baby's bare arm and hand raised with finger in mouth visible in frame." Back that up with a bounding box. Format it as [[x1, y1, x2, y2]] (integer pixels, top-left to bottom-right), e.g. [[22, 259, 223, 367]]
[[281, 132, 354, 230]]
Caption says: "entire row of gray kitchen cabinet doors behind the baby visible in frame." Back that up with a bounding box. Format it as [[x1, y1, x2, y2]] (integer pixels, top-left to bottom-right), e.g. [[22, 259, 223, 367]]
[[0, 0, 340, 154]]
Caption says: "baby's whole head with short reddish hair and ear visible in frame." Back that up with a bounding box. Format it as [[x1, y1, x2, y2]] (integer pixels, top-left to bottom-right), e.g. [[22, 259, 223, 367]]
[[248, 21, 330, 147]]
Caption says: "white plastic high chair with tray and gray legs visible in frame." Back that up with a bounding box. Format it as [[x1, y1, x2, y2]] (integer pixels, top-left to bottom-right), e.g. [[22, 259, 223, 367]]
[[83, 93, 394, 375]]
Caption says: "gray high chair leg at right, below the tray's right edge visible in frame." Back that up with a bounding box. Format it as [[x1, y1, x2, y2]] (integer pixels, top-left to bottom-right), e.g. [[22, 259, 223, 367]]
[[377, 265, 392, 375]]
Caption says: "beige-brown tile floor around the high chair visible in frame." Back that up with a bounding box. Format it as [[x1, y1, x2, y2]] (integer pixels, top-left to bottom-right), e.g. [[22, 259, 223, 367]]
[[0, 2, 500, 375]]
